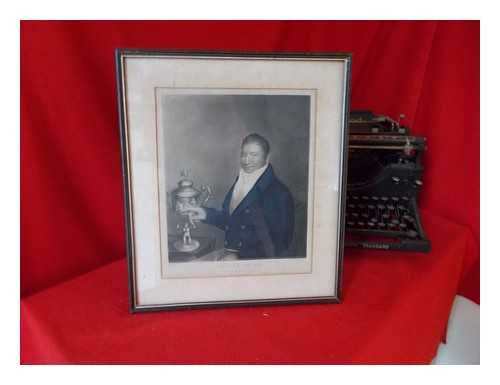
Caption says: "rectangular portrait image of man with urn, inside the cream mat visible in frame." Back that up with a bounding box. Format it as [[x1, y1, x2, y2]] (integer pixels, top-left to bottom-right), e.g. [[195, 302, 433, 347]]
[[159, 90, 311, 263]]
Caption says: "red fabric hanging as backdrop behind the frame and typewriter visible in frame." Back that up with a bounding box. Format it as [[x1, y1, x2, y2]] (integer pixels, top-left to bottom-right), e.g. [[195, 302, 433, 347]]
[[21, 21, 479, 302]]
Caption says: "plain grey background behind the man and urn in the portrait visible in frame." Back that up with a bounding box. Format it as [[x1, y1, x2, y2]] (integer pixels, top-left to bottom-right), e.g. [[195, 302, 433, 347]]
[[158, 94, 310, 256]]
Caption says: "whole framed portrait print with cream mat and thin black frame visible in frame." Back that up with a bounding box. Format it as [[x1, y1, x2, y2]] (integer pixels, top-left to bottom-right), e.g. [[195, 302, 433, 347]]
[[116, 50, 351, 312]]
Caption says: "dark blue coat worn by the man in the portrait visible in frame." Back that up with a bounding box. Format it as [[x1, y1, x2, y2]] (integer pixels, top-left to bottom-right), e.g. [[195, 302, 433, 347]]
[[205, 165, 294, 259]]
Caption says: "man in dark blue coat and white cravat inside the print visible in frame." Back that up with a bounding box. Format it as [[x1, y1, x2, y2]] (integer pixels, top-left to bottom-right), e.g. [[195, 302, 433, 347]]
[[182, 133, 295, 260]]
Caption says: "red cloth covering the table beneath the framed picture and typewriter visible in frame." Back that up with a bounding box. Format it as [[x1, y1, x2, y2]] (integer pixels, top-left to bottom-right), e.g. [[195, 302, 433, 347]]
[[21, 213, 473, 364]]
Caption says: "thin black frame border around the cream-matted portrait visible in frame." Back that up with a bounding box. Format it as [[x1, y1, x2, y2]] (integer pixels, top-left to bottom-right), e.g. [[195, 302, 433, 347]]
[[115, 48, 352, 313]]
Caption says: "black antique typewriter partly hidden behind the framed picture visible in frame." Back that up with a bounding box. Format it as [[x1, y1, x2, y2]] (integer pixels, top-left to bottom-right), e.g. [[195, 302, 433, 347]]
[[345, 111, 430, 252]]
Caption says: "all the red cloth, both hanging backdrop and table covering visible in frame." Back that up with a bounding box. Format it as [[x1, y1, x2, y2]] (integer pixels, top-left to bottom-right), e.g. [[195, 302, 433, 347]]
[[21, 21, 479, 363]]
